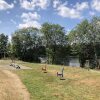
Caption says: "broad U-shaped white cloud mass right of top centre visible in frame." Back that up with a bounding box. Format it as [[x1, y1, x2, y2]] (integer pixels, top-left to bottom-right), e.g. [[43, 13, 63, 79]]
[[53, 0, 89, 19]]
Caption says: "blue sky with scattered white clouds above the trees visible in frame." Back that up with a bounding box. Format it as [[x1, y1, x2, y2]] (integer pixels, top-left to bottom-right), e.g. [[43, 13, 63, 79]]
[[0, 0, 100, 37]]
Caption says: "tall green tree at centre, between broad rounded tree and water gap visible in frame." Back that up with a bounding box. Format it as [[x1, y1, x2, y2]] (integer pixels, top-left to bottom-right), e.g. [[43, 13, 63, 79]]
[[41, 23, 69, 64]]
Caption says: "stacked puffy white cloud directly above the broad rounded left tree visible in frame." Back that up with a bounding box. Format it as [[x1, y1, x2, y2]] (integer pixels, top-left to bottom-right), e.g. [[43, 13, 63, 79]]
[[18, 12, 41, 28]]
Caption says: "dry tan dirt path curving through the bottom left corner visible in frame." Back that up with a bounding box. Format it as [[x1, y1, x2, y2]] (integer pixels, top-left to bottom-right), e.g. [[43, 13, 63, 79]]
[[0, 70, 30, 100]]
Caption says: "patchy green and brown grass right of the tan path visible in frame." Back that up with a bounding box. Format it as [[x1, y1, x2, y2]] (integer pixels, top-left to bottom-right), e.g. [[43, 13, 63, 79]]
[[13, 62, 100, 100]]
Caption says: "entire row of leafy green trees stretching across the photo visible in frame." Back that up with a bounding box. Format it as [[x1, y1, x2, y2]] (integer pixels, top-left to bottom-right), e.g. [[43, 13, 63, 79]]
[[0, 17, 100, 68]]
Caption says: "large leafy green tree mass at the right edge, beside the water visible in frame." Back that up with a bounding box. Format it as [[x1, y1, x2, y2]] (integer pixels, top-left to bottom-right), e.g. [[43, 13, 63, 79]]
[[69, 17, 100, 68]]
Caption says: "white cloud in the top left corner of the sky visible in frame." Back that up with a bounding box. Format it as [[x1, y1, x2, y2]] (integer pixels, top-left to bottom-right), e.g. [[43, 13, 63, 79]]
[[0, 0, 14, 10]]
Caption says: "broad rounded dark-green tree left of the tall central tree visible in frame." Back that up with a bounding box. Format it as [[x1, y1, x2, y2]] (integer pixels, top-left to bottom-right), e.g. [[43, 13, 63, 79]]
[[12, 27, 45, 62]]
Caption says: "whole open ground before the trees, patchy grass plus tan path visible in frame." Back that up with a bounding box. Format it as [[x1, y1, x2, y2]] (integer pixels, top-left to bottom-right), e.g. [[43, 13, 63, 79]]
[[0, 60, 100, 100]]
